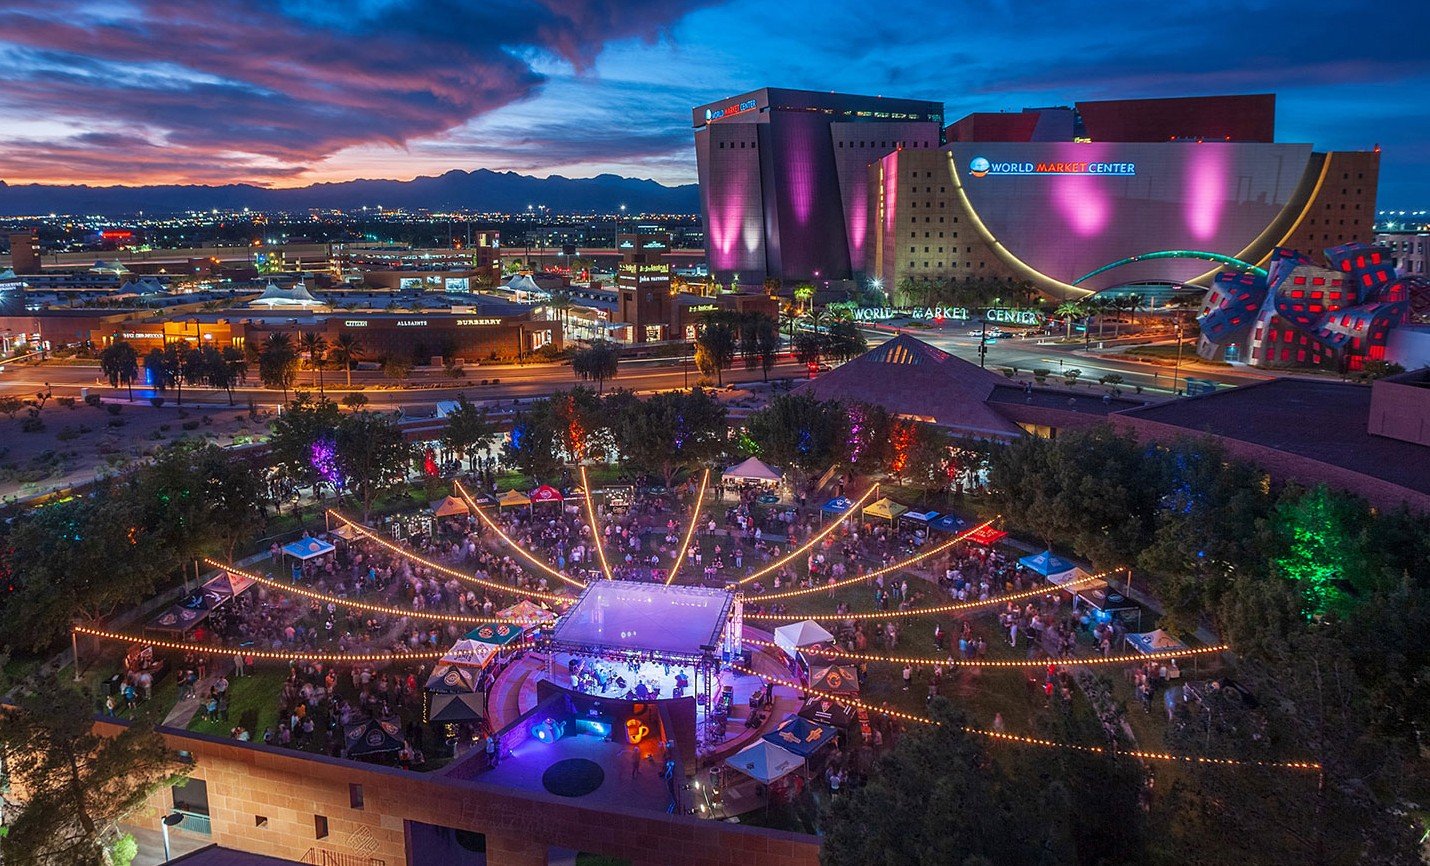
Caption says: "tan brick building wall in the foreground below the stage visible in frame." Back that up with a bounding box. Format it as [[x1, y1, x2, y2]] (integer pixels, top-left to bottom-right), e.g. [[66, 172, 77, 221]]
[[117, 720, 819, 866]]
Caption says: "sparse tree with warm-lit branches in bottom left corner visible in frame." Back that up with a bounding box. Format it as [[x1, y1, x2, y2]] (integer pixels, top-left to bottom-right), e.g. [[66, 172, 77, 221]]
[[0, 676, 186, 866]]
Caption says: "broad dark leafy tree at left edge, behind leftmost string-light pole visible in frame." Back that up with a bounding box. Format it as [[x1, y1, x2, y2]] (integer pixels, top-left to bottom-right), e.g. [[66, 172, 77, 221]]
[[0, 484, 179, 652]]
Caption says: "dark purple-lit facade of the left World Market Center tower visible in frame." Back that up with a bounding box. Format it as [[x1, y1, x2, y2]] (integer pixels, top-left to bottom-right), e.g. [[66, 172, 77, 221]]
[[692, 89, 944, 283]]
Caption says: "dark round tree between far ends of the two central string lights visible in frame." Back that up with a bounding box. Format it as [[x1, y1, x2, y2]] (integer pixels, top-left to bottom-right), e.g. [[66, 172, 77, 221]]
[[615, 387, 726, 487]]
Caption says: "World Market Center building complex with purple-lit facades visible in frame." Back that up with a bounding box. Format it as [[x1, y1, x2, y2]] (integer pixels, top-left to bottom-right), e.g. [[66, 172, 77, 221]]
[[695, 89, 1380, 307]]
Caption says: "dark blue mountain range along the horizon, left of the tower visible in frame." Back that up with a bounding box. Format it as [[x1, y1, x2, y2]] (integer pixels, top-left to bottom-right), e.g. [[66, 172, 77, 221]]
[[0, 169, 699, 216]]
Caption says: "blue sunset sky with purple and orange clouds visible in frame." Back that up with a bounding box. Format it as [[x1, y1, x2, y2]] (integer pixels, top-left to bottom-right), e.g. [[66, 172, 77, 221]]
[[0, 0, 1430, 209]]
